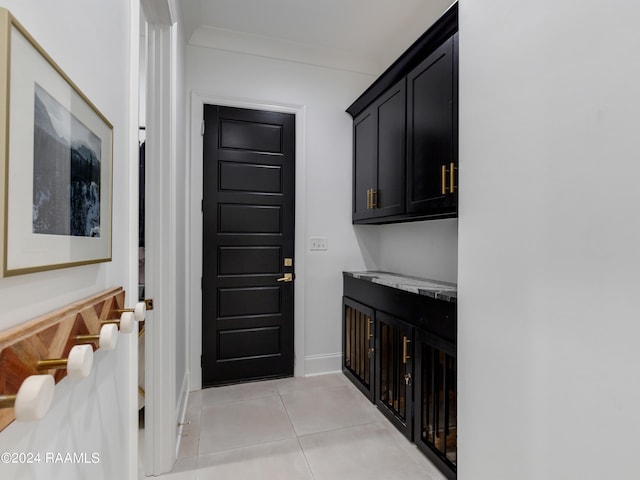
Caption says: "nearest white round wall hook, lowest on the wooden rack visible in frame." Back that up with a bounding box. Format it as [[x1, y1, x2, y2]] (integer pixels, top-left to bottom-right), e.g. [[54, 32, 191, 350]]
[[0, 375, 56, 422]]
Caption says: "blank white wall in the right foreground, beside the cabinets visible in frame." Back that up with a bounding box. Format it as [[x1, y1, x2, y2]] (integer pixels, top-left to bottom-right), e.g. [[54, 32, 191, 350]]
[[458, 0, 640, 480]]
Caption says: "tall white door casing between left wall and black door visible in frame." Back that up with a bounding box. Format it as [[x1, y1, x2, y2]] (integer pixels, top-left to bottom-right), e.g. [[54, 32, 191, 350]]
[[141, 0, 177, 476]]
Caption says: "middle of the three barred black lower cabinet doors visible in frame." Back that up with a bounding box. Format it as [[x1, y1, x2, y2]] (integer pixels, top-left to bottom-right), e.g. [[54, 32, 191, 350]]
[[376, 312, 413, 440]]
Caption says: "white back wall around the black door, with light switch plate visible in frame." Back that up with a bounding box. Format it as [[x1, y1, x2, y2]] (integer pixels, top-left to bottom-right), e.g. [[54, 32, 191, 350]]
[[187, 46, 373, 385]]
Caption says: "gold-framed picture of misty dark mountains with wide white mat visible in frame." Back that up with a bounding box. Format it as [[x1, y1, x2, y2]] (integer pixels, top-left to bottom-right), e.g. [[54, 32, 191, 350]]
[[0, 9, 113, 276]]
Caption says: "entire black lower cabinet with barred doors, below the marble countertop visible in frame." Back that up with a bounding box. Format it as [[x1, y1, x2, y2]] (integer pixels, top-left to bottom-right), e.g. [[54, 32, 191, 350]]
[[342, 274, 458, 479]]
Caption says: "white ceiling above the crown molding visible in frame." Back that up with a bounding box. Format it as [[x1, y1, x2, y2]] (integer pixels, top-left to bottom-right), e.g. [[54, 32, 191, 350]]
[[179, 0, 452, 74]]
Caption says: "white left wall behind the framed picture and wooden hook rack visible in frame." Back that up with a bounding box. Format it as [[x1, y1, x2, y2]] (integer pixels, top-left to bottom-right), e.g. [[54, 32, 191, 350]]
[[0, 0, 137, 480]]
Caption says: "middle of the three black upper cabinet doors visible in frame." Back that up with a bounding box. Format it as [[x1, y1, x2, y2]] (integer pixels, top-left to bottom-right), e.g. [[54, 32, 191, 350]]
[[373, 79, 407, 217]]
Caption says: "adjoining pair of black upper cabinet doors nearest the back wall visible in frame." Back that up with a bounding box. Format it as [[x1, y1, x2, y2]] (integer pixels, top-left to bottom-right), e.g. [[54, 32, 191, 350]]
[[353, 79, 406, 221]]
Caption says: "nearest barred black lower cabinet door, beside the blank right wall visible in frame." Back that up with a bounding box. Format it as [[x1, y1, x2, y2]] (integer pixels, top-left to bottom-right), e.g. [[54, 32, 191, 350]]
[[414, 330, 458, 479]]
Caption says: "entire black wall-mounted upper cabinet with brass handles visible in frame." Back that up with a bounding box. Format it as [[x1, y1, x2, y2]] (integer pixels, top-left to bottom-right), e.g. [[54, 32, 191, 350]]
[[347, 4, 458, 223]]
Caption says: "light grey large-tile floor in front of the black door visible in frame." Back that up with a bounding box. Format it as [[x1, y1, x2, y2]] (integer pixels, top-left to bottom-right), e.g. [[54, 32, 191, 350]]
[[139, 373, 445, 480]]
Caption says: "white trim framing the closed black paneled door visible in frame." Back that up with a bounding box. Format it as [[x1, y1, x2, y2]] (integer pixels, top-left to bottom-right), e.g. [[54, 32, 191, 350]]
[[186, 91, 306, 391]]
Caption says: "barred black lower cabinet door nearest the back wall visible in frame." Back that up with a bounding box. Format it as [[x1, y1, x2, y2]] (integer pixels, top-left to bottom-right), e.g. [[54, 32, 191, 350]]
[[342, 297, 375, 402]]
